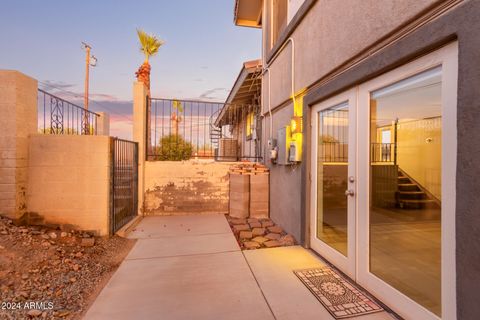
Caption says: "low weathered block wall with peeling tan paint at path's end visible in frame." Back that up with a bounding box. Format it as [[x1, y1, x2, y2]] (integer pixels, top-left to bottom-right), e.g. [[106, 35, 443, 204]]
[[143, 160, 232, 215]]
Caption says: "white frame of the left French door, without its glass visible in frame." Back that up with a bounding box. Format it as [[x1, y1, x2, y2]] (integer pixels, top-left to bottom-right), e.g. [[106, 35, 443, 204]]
[[310, 89, 357, 279]]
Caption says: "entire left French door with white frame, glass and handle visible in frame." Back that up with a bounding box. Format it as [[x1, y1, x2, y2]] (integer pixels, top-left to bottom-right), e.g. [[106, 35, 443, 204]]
[[310, 90, 357, 279]]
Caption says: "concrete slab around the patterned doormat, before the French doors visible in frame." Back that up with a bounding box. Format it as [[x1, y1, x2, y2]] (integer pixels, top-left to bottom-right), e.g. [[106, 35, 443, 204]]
[[243, 246, 395, 320]]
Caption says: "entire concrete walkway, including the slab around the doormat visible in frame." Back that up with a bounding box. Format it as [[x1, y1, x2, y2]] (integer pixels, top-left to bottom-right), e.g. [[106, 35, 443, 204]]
[[85, 215, 392, 320]]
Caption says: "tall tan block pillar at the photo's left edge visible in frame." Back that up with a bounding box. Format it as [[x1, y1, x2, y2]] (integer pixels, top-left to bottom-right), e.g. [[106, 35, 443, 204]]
[[0, 70, 37, 219]]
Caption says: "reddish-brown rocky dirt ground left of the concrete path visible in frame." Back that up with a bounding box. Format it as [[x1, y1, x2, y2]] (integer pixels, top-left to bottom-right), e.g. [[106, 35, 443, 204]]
[[0, 217, 135, 319]]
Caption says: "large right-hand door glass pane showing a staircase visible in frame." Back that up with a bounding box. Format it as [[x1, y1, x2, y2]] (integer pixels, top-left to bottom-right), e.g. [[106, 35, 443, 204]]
[[369, 67, 442, 316]]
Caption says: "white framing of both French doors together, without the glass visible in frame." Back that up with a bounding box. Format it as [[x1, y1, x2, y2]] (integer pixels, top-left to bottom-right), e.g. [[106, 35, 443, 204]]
[[310, 42, 458, 320]]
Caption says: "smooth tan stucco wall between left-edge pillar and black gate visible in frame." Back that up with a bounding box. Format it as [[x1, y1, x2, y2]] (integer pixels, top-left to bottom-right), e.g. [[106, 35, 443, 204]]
[[27, 134, 111, 235]]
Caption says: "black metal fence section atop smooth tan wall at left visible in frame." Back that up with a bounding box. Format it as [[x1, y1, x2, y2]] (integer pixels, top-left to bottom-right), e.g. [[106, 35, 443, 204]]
[[37, 89, 99, 135]]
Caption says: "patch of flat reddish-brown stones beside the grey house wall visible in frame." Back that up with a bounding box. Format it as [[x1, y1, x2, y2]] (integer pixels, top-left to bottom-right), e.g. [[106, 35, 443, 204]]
[[227, 215, 295, 250]]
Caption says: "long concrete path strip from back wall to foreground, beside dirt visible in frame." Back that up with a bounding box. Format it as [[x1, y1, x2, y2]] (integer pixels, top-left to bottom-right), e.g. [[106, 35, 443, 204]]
[[85, 215, 274, 320]]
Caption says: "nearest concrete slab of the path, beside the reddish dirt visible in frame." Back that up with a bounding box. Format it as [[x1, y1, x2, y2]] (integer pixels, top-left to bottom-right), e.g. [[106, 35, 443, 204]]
[[85, 252, 274, 320]]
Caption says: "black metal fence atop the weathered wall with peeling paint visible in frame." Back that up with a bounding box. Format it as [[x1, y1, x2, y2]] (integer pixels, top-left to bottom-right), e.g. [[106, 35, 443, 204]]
[[146, 98, 260, 161]]
